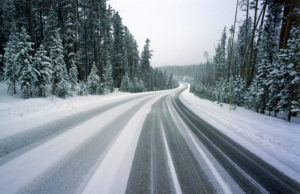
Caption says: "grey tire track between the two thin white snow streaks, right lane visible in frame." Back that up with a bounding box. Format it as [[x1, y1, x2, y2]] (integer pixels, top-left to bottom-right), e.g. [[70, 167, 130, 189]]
[[159, 98, 216, 194]]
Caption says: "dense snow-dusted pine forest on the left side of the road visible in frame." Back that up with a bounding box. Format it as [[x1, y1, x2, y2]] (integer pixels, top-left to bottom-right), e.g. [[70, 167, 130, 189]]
[[0, 0, 178, 98]]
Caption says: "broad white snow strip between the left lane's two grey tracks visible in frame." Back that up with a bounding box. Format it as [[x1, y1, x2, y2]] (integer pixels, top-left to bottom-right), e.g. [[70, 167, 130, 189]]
[[0, 93, 157, 193]]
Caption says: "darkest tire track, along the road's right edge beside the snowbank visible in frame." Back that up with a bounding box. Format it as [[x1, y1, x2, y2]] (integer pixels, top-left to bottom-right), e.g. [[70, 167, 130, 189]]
[[172, 87, 300, 193]]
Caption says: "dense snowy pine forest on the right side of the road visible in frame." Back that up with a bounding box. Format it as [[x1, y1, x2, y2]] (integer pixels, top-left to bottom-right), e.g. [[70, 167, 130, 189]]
[[191, 0, 300, 120]]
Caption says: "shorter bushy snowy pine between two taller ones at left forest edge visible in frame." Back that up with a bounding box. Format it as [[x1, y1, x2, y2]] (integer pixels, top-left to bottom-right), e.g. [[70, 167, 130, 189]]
[[34, 45, 53, 97]]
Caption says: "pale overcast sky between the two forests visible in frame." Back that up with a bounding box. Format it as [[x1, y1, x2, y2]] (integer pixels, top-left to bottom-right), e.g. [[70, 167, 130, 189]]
[[108, 0, 241, 67]]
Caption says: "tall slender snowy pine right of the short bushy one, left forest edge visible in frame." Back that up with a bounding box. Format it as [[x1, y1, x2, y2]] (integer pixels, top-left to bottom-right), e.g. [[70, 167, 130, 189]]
[[50, 30, 70, 97]]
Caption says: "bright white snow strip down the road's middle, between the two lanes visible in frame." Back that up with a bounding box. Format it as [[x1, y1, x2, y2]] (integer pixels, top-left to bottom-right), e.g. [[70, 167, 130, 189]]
[[83, 91, 176, 193]]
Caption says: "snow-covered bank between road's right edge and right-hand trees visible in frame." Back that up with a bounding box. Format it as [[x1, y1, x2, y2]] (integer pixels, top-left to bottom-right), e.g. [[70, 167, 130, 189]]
[[180, 84, 300, 182]]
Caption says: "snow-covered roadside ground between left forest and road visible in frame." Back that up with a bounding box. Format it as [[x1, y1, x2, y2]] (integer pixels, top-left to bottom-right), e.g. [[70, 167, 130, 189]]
[[0, 83, 162, 139]]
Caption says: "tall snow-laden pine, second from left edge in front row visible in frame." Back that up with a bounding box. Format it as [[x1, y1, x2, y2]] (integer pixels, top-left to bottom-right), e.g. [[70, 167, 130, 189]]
[[15, 28, 38, 98]]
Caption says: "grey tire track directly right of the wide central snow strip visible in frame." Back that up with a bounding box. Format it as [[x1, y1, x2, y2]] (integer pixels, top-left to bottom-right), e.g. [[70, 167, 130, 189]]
[[126, 97, 175, 194]]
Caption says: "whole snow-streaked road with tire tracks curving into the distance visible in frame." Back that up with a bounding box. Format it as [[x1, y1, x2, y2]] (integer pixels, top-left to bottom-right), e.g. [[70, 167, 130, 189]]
[[0, 86, 300, 194]]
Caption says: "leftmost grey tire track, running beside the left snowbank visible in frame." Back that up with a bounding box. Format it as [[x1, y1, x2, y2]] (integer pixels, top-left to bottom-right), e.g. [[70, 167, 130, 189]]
[[0, 91, 155, 165]]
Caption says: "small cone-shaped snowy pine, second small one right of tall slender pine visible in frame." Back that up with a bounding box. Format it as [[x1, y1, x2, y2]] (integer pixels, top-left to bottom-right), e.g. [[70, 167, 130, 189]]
[[87, 64, 101, 94]]
